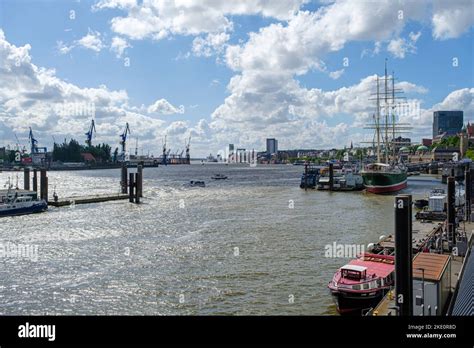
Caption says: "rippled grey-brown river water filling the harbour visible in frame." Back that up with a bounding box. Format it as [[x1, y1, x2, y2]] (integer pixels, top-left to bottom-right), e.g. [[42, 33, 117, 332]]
[[0, 164, 442, 315]]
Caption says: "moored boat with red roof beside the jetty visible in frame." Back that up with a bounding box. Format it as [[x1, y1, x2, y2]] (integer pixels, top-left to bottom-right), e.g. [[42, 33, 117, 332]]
[[328, 253, 395, 314]]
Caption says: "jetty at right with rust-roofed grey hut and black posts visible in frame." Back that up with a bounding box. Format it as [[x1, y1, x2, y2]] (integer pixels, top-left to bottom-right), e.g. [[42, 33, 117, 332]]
[[365, 169, 474, 316]]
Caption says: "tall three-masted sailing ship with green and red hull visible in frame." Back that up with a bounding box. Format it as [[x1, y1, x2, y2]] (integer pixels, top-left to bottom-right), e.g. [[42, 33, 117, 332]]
[[361, 62, 409, 193]]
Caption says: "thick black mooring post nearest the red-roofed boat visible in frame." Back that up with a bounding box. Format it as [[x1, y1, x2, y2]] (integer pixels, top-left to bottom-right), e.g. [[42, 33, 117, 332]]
[[395, 195, 413, 316]]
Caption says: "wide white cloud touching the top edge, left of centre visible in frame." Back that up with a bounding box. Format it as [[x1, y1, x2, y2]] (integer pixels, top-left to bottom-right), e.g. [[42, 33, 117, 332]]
[[93, 0, 308, 40]]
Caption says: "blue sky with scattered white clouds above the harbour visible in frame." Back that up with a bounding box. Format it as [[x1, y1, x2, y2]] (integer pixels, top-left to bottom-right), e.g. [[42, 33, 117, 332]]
[[0, 0, 474, 157]]
